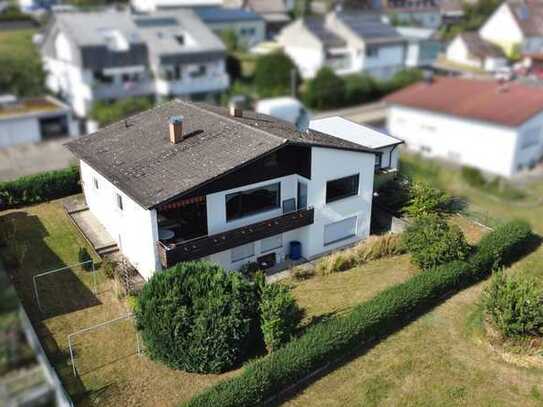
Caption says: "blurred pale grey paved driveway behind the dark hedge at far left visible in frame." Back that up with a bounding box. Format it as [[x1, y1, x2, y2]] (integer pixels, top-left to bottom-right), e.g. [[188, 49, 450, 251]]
[[0, 138, 77, 181]]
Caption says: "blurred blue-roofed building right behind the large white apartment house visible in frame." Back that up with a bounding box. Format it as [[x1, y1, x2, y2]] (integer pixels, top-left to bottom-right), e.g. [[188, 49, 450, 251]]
[[195, 7, 266, 48]]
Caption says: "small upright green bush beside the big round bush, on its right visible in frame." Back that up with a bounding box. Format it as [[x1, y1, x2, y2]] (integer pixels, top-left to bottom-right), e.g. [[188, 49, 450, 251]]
[[260, 284, 301, 352]]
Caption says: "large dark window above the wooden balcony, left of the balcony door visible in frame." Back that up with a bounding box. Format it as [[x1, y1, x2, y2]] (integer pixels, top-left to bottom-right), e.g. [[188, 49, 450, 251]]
[[226, 182, 281, 222]]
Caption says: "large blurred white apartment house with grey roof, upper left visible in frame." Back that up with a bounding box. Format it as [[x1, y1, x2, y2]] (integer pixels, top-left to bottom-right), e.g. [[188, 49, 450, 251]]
[[40, 9, 229, 117]]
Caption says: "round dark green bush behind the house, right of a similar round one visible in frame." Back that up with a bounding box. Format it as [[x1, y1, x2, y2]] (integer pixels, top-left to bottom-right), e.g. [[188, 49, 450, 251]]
[[303, 67, 345, 110]]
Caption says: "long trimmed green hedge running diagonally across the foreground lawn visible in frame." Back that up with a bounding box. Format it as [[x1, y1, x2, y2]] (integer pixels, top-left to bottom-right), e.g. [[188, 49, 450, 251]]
[[186, 221, 531, 407]]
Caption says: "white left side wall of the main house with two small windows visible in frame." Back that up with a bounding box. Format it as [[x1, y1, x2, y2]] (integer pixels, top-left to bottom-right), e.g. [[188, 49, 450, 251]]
[[81, 161, 161, 279]]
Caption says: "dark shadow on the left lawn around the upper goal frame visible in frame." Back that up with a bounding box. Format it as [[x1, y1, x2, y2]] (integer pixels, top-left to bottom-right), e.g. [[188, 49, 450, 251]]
[[0, 211, 101, 320]]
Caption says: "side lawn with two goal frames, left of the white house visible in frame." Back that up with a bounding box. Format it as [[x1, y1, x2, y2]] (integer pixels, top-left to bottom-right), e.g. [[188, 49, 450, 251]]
[[0, 201, 236, 406]]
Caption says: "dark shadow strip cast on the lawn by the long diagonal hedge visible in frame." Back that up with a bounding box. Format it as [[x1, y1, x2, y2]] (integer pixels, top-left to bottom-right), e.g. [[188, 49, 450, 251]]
[[264, 234, 543, 406]]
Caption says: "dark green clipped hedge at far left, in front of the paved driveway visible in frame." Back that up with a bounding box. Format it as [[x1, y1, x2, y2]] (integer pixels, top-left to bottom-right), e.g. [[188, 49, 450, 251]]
[[0, 167, 81, 208]]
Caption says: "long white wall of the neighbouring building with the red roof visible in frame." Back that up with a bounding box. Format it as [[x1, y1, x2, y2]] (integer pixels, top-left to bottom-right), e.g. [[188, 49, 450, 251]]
[[387, 105, 517, 177]]
